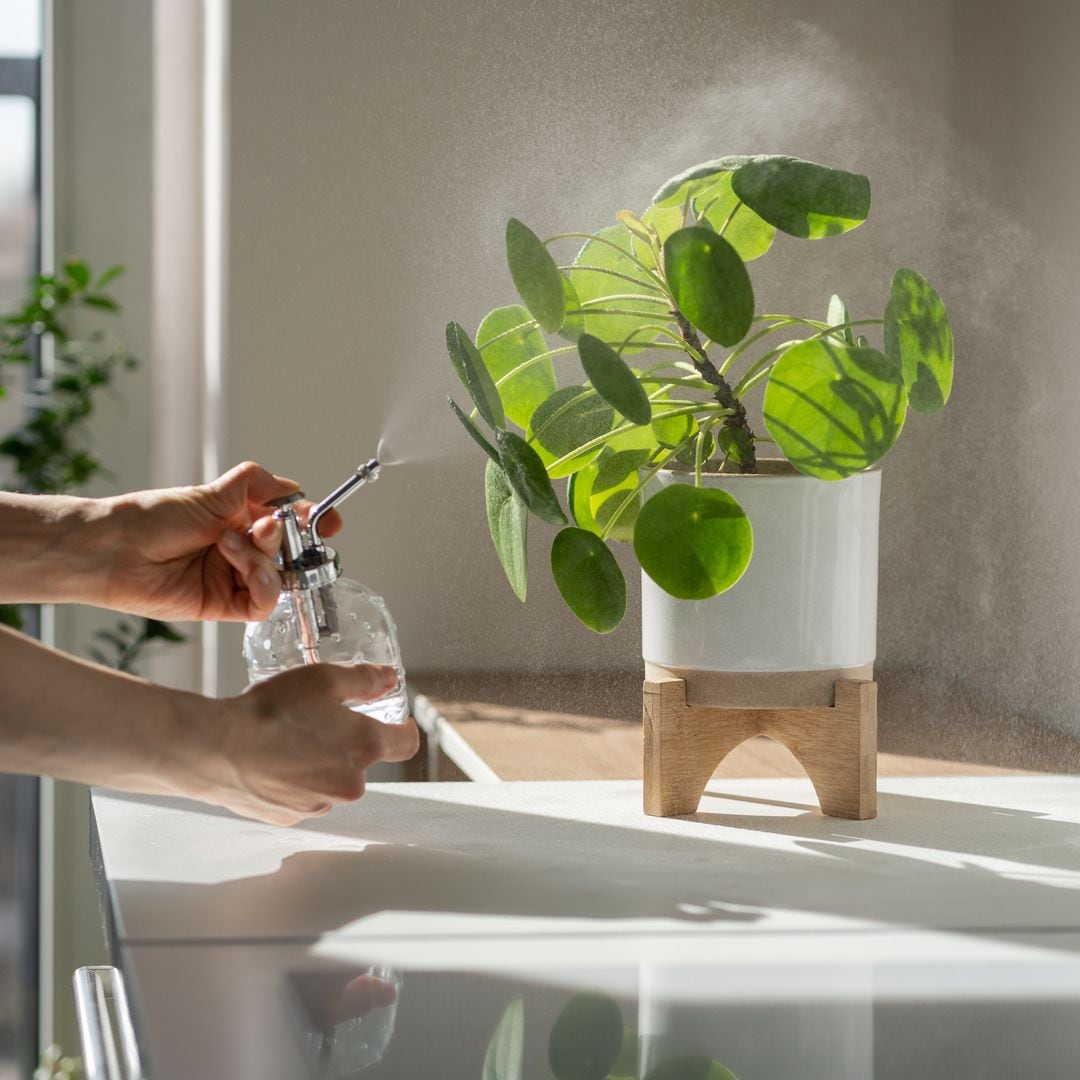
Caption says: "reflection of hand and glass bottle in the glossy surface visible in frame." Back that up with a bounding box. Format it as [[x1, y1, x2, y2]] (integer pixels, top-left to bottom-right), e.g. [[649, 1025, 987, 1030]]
[[291, 964, 402, 1080]]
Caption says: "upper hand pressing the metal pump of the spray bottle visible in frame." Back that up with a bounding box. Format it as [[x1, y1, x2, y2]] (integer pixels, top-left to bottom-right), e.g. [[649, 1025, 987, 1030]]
[[100, 461, 341, 621]]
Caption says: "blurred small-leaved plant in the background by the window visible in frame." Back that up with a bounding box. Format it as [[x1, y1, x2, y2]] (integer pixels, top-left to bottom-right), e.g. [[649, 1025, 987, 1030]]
[[0, 258, 184, 671]]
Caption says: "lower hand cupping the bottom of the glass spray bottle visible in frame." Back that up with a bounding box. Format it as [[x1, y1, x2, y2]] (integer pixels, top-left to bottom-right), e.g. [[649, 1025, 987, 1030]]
[[191, 664, 420, 825]]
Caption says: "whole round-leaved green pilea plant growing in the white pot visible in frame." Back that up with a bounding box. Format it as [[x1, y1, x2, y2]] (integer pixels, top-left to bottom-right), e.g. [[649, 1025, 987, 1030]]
[[446, 156, 953, 633]]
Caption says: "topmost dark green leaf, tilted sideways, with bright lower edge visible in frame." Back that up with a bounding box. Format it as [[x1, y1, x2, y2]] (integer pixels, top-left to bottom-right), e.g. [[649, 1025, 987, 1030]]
[[731, 157, 870, 240]]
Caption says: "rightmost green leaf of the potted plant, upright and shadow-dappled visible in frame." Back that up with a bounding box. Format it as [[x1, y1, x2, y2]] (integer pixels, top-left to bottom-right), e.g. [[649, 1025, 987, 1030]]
[[885, 269, 953, 413]]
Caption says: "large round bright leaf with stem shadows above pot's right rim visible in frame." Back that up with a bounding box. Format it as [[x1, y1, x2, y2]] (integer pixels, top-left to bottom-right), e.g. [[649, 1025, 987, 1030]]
[[764, 338, 907, 480]]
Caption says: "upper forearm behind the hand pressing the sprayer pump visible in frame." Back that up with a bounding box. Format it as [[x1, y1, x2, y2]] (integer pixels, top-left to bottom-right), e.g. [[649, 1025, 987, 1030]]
[[0, 491, 113, 604]]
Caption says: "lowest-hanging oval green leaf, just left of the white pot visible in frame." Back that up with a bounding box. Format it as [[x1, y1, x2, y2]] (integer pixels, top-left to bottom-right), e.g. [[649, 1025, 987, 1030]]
[[551, 526, 626, 630]]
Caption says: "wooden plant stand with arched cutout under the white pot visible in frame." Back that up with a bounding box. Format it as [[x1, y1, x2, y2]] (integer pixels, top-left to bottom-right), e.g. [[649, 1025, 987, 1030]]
[[643, 678, 877, 820]]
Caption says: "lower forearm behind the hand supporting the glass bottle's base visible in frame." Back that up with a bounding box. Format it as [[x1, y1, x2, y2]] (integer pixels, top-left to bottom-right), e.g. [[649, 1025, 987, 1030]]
[[0, 629, 217, 796]]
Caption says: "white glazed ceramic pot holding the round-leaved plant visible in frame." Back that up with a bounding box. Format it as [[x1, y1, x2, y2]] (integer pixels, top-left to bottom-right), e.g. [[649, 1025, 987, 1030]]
[[642, 460, 881, 704]]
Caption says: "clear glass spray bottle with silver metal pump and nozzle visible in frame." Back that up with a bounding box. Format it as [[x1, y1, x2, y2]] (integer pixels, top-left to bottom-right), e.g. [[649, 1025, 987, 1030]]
[[244, 458, 408, 724]]
